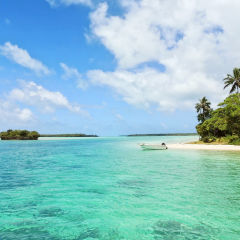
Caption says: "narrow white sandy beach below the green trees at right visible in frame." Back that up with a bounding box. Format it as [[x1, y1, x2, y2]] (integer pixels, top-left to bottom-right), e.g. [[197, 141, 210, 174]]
[[167, 143, 240, 151]]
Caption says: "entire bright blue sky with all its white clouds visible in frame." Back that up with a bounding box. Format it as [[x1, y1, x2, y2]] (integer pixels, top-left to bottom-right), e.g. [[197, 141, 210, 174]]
[[0, 0, 240, 136]]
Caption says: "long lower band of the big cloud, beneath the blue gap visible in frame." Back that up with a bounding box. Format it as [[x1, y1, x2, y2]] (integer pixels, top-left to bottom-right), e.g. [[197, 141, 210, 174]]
[[88, 68, 221, 111]]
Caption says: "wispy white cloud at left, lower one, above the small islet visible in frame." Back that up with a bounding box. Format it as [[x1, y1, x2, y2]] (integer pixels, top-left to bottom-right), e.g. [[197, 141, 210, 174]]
[[9, 81, 87, 115]]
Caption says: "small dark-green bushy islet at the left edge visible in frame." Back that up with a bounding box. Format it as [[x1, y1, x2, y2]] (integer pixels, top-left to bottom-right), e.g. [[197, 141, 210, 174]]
[[0, 129, 40, 140]]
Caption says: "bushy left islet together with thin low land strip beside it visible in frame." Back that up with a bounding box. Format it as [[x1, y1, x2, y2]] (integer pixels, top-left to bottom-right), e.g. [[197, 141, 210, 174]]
[[0, 129, 98, 140]]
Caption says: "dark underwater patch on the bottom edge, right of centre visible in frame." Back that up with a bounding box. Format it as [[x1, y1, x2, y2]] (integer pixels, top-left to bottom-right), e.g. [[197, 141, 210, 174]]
[[153, 221, 217, 240]]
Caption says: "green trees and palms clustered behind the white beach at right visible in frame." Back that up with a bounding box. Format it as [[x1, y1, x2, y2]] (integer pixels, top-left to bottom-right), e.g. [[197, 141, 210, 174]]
[[195, 68, 240, 145]]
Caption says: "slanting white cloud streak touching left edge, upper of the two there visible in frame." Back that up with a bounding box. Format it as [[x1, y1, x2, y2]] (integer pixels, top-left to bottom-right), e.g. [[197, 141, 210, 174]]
[[0, 42, 50, 74]]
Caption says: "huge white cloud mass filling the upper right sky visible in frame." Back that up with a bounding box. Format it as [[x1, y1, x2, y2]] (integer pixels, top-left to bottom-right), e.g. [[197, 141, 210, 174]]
[[88, 0, 240, 110]]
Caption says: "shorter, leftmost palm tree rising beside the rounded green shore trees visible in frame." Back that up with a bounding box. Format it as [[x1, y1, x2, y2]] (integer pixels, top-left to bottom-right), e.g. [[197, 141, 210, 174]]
[[195, 97, 212, 123]]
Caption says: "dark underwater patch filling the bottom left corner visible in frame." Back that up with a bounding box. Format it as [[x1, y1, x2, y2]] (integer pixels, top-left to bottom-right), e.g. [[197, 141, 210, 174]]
[[0, 227, 60, 240]]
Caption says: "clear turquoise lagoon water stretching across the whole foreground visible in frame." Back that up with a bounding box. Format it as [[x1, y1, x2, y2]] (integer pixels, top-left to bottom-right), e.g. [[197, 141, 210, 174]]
[[0, 137, 240, 240]]
